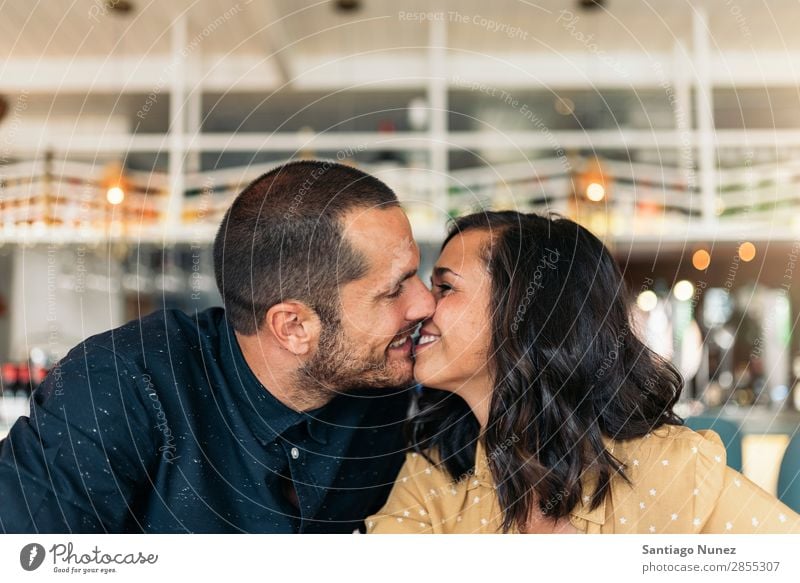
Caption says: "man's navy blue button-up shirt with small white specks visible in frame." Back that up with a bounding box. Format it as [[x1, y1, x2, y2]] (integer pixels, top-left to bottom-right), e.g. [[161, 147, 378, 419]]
[[0, 308, 410, 533]]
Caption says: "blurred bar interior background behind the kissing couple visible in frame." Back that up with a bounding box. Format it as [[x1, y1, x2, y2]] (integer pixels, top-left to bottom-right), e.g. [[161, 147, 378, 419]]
[[0, 0, 800, 510]]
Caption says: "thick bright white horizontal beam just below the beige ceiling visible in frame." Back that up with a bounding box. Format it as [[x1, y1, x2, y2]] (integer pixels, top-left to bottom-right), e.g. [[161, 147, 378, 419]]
[[0, 49, 800, 93]]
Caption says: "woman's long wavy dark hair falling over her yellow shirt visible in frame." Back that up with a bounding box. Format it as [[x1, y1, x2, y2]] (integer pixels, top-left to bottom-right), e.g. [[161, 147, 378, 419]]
[[408, 211, 683, 532]]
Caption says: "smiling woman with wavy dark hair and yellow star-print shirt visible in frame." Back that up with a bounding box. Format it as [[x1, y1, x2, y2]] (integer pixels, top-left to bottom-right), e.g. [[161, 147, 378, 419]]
[[367, 212, 800, 533]]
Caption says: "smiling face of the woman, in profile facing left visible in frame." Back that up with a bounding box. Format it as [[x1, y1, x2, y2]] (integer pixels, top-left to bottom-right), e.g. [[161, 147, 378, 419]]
[[414, 230, 491, 421]]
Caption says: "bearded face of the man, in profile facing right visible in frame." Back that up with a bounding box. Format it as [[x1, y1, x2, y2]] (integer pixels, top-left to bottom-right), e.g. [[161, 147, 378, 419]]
[[304, 207, 434, 391]]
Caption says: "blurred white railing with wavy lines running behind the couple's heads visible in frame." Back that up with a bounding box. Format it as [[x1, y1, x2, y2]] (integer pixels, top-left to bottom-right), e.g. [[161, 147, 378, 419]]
[[0, 156, 800, 243]]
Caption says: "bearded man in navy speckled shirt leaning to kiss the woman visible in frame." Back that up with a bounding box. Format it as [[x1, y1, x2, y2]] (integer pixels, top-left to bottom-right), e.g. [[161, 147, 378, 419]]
[[0, 161, 434, 533]]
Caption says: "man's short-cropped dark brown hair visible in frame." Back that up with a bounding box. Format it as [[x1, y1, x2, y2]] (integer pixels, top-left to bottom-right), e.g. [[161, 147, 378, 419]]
[[214, 160, 399, 335]]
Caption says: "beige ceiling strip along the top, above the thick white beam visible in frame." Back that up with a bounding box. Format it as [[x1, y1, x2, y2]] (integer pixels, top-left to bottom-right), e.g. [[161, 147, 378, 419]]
[[0, 0, 800, 63]]
